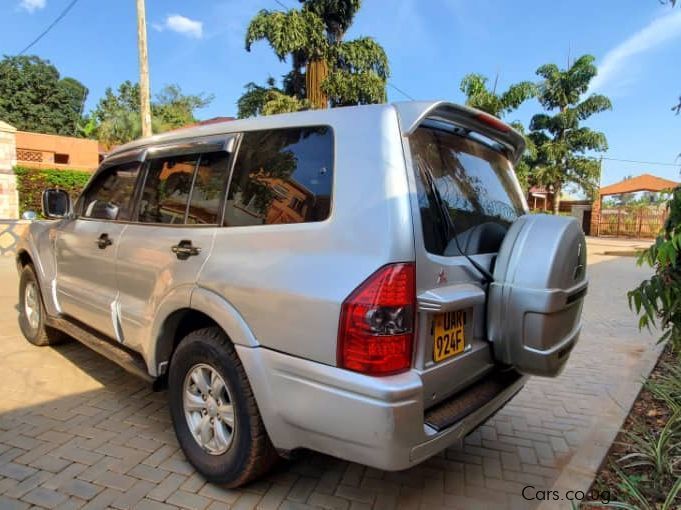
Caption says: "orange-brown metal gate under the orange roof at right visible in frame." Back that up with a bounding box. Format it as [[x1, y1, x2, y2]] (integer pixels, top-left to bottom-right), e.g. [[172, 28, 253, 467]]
[[598, 207, 667, 238]]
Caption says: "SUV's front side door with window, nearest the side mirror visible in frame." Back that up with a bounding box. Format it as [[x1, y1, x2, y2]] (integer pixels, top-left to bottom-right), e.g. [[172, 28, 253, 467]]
[[55, 153, 141, 338]]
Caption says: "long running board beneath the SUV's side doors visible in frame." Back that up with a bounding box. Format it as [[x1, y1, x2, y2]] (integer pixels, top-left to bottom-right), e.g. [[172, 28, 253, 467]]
[[47, 317, 155, 383]]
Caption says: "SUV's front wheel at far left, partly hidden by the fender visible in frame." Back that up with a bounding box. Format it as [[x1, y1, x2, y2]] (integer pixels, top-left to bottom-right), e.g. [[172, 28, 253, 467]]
[[19, 265, 66, 347]]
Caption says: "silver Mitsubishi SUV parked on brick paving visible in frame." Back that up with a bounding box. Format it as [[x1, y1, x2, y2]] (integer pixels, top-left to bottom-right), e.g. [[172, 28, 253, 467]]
[[17, 102, 587, 486]]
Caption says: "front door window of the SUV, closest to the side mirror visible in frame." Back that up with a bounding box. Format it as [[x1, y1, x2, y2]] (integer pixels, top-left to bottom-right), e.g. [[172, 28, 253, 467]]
[[82, 162, 141, 220]]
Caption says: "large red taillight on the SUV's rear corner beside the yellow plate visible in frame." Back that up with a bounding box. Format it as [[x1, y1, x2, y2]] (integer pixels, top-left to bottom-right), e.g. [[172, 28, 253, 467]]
[[338, 263, 416, 375]]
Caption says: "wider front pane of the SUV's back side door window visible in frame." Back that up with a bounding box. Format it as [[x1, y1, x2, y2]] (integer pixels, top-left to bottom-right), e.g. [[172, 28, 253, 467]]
[[138, 155, 198, 224]]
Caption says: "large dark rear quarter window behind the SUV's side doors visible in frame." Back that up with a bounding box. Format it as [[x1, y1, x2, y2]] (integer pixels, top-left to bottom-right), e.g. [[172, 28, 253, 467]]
[[224, 127, 333, 226]]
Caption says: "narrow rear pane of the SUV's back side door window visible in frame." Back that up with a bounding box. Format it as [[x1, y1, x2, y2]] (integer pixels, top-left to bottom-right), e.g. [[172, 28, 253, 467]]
[[187, 152, 229, 224]]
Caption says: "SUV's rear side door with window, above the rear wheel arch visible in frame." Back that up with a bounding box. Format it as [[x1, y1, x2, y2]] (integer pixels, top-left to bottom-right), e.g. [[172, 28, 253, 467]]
[[116, 136, 234, 351]]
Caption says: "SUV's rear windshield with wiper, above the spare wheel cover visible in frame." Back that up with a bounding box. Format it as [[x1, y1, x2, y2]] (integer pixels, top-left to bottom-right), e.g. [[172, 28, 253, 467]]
[[410, 127, 524, 256]]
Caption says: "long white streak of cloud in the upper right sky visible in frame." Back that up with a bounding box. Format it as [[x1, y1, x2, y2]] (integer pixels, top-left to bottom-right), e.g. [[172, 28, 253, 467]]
[[589, 9, 681, 92]]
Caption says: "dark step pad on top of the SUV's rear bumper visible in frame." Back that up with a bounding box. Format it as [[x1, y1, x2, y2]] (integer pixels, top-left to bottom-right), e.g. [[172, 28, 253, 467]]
[[424, 370, 522, 432]]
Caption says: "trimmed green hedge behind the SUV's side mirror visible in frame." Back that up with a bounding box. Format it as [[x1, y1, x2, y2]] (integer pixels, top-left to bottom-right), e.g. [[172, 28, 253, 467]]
[[14, 166, 92, 215]]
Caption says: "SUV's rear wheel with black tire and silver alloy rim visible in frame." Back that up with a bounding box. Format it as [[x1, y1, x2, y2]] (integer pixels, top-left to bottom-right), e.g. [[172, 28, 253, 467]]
[[168, 328, 277, 487]]
